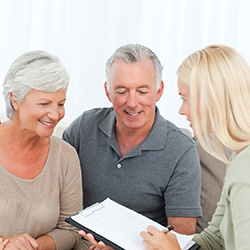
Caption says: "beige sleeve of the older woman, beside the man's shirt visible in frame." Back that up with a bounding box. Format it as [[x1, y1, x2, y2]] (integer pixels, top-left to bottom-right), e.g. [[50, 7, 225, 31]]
[[48, 148, 83, 250]]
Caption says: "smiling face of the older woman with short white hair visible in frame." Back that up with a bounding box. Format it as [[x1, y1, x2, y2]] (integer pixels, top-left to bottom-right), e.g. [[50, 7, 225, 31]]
[[11, 90, 66, 137]]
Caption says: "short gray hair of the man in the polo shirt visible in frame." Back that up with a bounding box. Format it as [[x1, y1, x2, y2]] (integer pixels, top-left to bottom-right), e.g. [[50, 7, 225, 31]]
[[106, 44, 163, 91]]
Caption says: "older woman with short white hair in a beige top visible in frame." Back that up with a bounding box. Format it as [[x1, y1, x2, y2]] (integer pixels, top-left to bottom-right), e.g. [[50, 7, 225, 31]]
[[0, 51, 85, 250]]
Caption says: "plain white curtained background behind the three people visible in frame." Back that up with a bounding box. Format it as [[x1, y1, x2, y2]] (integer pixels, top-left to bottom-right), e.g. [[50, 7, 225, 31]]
[[0, 0, 250, 127]]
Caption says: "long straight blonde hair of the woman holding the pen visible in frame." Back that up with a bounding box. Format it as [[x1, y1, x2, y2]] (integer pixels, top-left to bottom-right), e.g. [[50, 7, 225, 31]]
[[177, 45, 250, 163]]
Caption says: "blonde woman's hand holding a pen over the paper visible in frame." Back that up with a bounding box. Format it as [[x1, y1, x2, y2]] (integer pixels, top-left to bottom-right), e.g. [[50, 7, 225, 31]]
[[140, 226, 181, 250]]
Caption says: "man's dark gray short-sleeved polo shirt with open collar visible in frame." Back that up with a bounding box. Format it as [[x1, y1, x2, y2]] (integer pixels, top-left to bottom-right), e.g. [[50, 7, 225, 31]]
[[63, 108, 201, 225]]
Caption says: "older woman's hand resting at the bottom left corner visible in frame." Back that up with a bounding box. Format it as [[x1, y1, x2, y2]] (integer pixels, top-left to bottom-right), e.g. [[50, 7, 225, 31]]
[[3, 234, 42, 250]]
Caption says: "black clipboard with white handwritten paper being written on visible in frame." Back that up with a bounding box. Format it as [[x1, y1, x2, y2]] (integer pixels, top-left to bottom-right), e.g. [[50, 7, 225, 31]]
[[66, 198, 199, 250]]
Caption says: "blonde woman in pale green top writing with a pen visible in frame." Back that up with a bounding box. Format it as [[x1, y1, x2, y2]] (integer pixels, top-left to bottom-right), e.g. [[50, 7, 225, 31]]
[[141, 45, 250, 250]]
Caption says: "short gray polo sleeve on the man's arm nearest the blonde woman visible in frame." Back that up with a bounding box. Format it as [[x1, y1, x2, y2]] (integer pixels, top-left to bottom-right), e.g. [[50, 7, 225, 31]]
[[164, 143, 202, 217]]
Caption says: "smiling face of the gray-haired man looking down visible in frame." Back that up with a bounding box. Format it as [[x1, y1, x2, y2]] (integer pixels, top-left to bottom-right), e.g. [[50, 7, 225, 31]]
[[105, 59, 163, 132]]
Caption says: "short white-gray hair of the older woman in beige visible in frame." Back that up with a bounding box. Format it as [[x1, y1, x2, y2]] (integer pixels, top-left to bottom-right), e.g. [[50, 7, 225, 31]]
[[3, 50, 69, 119]]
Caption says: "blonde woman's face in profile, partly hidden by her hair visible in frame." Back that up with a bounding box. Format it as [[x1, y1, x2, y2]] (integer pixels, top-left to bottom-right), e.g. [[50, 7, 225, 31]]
[[178, 77, 193, 128]]
